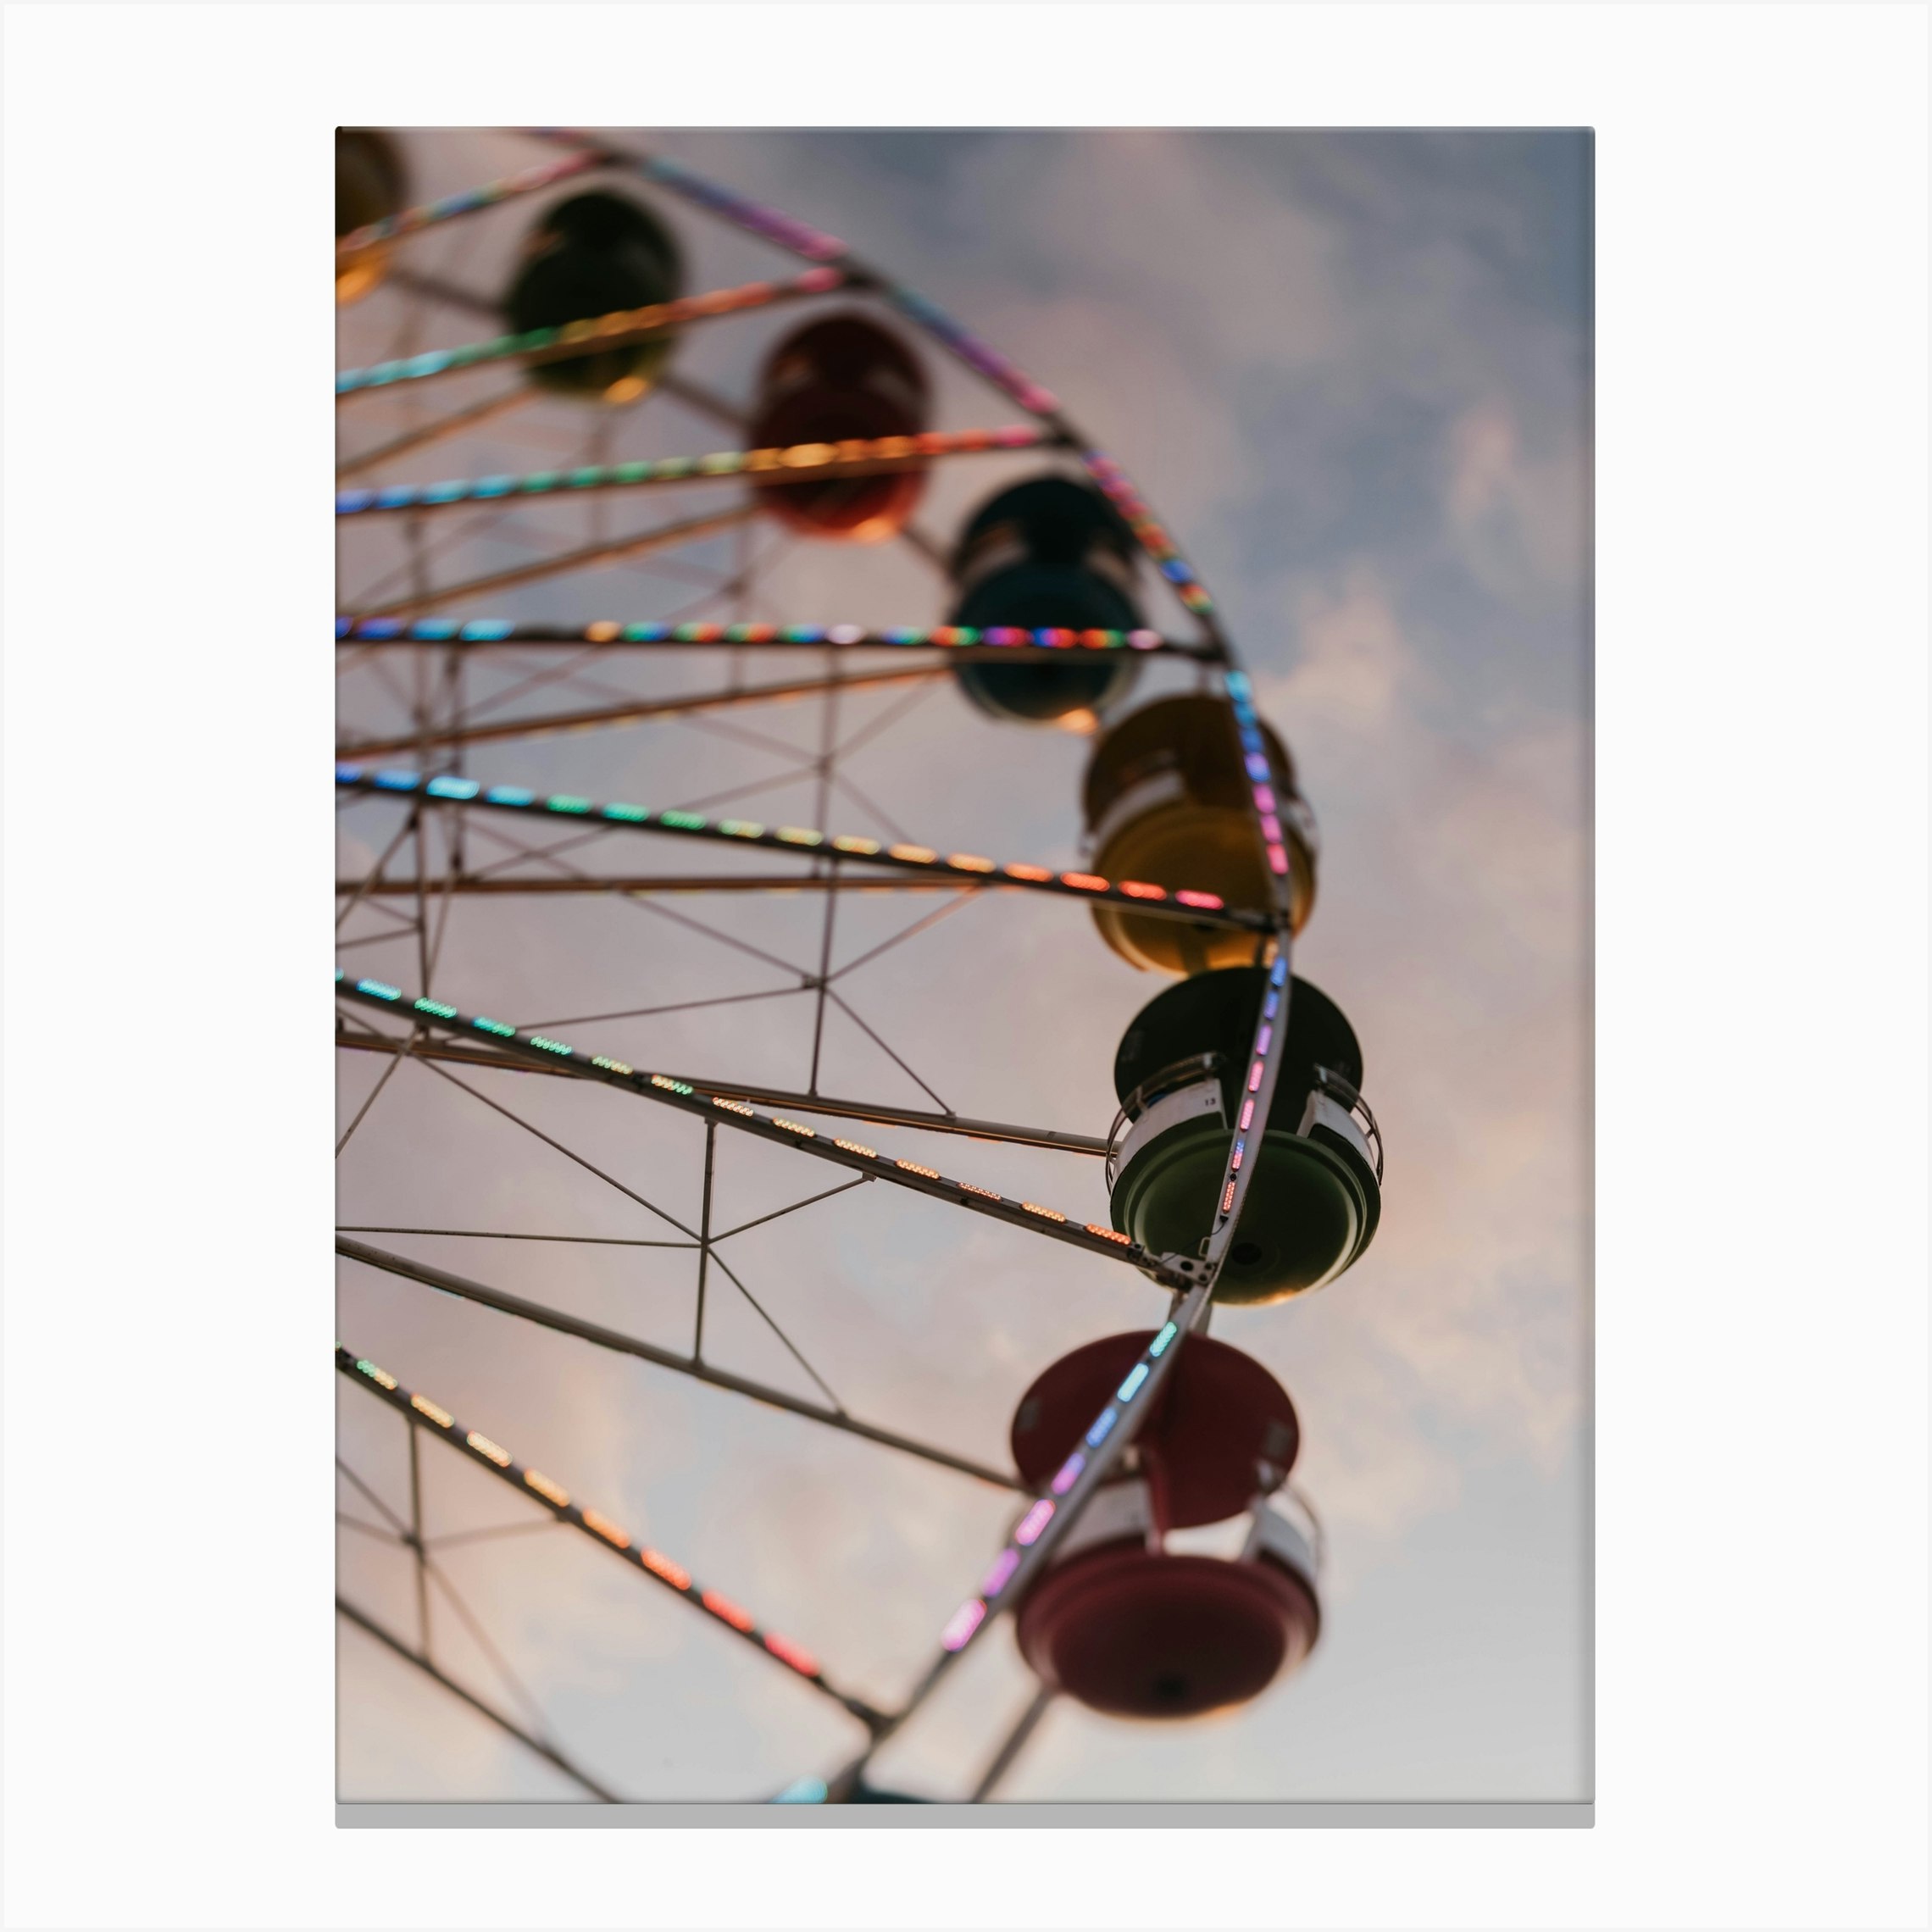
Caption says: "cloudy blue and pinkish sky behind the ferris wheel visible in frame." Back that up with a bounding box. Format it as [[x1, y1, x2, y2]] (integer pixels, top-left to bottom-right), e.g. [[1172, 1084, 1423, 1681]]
[[338, 130, 1590, 1801]]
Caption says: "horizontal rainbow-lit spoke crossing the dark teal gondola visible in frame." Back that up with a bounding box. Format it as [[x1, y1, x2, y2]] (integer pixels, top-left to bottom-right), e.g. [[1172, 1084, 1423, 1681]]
[[336, 616, 1209, 658]]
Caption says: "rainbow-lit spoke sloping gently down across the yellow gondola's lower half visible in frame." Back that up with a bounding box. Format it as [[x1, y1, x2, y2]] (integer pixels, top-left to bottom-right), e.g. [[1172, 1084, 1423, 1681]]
[[336, 765, 1274, 933]]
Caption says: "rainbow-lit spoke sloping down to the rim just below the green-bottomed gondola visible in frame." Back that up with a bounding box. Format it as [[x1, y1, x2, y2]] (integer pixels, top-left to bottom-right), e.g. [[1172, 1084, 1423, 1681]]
[[336, 980, 1185, 1286]]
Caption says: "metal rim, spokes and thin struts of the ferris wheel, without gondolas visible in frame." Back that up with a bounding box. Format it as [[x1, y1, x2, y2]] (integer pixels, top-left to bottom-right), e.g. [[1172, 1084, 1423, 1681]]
[[336, 130, 1289, 1801]]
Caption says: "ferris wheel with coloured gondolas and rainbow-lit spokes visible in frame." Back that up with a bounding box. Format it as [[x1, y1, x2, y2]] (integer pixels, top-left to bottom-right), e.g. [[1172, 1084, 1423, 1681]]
[[336, 130, 1383, 1802]]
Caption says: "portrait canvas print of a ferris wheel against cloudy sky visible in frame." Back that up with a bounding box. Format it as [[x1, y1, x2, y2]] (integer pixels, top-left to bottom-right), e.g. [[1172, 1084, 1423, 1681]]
[[336, 127, 1592, 1820]]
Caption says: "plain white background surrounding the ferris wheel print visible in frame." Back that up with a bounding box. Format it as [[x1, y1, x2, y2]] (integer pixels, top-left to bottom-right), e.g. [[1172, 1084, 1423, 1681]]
[[4, 6, 1928, 1926]]
